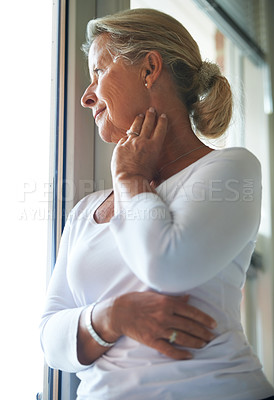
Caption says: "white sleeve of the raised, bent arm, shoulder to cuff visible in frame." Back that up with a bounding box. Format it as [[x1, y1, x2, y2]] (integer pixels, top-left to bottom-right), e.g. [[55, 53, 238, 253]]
[[111, 151, 261, 293]]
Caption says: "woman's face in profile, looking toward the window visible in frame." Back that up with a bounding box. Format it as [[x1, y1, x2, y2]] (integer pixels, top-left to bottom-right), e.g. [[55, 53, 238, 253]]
[[81, 34, 149, 143]]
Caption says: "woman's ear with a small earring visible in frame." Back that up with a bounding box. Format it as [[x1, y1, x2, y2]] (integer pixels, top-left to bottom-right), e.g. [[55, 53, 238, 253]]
[[142, 50, 163, 89]]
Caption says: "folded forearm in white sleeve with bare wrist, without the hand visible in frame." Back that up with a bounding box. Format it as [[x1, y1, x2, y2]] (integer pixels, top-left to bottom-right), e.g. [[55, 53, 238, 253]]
[[41, 299, 120, 372]]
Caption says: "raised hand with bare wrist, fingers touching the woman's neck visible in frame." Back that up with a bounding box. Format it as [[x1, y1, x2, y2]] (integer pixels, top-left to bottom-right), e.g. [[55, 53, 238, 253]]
[[111, 108, 167, 214]]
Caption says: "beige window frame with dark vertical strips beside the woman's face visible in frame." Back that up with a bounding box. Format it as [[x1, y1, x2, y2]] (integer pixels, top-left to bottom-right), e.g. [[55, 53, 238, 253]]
[[43, 0, 130, 400]]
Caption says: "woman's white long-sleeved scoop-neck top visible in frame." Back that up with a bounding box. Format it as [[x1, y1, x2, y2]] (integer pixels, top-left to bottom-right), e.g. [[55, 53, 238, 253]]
[[41, 148, 274, 400]]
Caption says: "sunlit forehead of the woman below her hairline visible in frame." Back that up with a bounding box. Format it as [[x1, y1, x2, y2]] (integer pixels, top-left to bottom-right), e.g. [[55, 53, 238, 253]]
[[88, 34, 112, 71]]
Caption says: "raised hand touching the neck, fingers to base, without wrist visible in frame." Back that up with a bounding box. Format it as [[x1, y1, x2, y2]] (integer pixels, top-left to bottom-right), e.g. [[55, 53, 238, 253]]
[[111, 107, 167, 182]]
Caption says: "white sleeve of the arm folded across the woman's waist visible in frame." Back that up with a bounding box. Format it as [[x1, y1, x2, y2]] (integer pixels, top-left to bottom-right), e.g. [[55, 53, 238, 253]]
[[40, 214, 87, 372]]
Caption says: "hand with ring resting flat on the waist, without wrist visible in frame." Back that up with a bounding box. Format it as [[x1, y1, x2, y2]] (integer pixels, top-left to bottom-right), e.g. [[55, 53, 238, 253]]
[[111, 292, 216, 360]]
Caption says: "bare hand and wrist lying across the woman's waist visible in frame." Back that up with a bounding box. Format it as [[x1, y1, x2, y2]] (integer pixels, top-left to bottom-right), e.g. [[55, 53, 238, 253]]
[[77, 292, 216, 365]]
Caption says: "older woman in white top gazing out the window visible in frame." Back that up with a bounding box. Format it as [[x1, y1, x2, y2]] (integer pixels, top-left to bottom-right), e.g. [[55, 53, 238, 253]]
[[41, 9, 273, 400]]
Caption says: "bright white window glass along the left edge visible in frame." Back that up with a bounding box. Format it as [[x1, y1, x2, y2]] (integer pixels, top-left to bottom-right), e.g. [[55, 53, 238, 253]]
[[0, 0, 52, 400]]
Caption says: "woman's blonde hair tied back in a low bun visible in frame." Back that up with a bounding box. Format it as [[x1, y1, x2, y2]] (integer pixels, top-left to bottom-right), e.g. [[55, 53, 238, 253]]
[[82, 8, 232, 138]]
